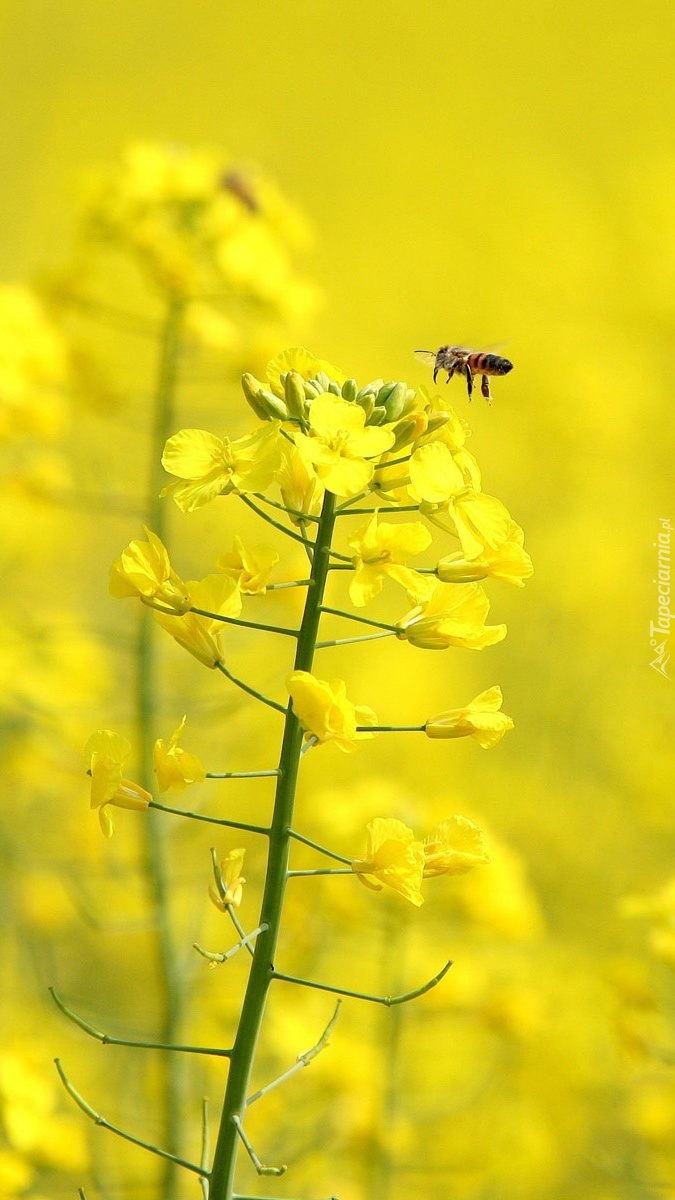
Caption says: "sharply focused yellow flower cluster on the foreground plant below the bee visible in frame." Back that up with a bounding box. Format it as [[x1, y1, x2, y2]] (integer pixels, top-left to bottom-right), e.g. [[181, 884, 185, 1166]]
[[97, 348, 532, 878]]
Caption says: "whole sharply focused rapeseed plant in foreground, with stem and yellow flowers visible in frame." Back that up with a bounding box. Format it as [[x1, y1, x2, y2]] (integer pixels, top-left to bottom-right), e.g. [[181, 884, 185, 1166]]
[[55, 337, 530, 1200]]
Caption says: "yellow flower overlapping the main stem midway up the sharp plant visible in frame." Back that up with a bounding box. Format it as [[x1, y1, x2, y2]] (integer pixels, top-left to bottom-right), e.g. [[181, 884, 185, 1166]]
[[286, 671, 377, 751]]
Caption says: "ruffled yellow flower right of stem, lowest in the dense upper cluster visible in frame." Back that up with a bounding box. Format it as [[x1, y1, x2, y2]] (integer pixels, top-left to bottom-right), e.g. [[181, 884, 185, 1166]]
[[396, 583, 507, 650]]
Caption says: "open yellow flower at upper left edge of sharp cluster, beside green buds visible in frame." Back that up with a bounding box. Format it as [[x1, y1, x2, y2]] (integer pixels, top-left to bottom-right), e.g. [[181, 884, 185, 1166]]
[[162, 421, 281, 512]]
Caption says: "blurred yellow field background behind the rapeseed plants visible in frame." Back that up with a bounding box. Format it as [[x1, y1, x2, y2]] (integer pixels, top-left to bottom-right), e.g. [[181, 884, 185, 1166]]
[[0, 0, 675, 1200]]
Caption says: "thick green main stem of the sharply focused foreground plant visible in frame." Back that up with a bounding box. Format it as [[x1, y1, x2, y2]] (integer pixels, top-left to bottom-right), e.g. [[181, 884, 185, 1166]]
[[210, 492, 335, 1200]]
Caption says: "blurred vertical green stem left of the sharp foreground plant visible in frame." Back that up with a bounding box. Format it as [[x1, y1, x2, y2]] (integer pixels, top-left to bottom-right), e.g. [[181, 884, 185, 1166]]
[[136, 296, 185, 1200]]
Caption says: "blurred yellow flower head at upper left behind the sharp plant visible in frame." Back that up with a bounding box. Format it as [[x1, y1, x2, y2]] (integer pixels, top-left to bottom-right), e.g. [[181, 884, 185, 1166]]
[[77, 142, 317, 324]]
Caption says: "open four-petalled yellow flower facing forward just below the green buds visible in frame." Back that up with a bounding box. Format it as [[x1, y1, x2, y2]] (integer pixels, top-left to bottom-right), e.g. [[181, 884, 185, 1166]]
[[293, 392, 394, 496]]
